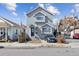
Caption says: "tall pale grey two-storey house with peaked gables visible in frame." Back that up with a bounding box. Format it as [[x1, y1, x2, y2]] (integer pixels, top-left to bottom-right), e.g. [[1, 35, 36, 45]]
[[27, 7, 56, 38]]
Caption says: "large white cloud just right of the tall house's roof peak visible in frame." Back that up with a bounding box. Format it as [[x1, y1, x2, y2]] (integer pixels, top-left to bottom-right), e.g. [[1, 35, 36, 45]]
[[38, 3, 60, 15]]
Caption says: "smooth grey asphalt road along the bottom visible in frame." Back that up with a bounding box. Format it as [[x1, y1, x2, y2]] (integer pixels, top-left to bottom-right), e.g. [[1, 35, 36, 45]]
[[0, 48, 79, 56]]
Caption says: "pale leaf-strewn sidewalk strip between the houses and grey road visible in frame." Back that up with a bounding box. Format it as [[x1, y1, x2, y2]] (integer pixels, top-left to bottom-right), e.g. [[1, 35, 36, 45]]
[[0, 40, 79, 49]]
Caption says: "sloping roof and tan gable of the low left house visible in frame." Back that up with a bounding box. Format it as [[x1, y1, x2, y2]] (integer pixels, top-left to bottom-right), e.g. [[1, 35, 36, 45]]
[[0, 16, 20, 27]]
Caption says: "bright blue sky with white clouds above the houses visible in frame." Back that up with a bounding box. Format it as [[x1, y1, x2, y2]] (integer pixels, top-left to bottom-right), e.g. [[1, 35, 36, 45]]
[[0, 3, 79, 25]]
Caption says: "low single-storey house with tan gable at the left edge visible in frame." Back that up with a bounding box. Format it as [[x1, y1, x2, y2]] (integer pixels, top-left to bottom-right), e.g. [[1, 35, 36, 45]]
[[0, 17, 21, 41]]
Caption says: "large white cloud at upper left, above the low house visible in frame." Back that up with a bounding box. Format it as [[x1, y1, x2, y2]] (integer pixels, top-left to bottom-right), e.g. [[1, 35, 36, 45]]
[[4, 3, 17, 16]]
